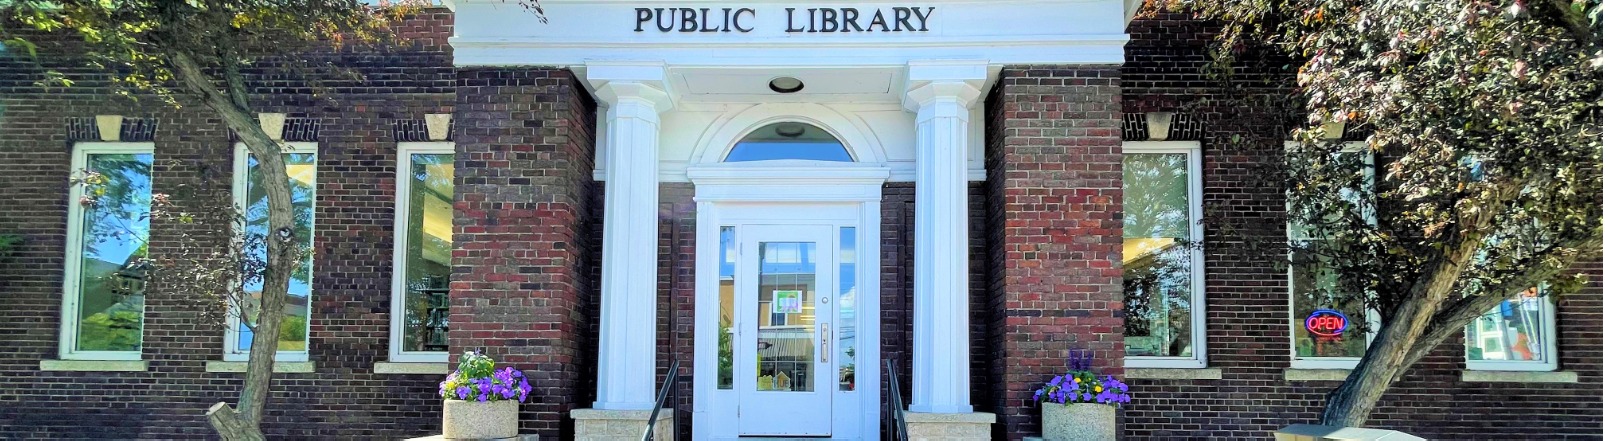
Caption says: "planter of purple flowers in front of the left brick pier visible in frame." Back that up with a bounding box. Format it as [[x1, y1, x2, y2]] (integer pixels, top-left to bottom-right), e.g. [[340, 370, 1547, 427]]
[[440, 351, 530, 439]]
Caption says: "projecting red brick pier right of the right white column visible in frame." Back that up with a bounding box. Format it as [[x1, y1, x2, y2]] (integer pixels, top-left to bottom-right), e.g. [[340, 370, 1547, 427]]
[[985, 66, 1124, 439]]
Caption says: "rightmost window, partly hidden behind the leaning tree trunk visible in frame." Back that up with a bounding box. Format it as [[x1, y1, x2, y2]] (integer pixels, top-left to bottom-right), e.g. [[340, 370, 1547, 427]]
[[1465, 289, 1555, 370]]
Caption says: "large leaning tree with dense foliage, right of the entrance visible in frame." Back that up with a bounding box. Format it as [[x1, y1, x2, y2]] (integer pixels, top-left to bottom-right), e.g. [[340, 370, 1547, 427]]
[[1156, 0, 1602, 427]]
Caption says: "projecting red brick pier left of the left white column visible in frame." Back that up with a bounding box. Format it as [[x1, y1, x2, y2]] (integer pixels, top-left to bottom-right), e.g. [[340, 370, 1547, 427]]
[[449, 67, 599, 438]]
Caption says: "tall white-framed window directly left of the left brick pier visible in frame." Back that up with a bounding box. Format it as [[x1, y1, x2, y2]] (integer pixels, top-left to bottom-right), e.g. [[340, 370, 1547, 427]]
[[390, 143, 456, 362]]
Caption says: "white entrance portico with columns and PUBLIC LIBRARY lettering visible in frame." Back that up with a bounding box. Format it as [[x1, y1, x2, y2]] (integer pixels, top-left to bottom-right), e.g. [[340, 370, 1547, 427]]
[[451, 0, 1125, 439]]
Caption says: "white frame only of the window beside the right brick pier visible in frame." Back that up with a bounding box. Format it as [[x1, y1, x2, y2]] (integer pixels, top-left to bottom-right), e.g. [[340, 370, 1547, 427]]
[[1120, 141, 1209, 369]]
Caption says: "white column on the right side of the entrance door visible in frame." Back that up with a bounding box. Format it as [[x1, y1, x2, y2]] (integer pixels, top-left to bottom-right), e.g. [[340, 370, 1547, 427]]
[[904, 64, 985, 414]]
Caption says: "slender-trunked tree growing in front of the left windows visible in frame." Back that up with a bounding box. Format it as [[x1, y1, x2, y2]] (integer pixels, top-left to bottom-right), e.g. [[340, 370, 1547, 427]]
[[0, 0, 426, 439]]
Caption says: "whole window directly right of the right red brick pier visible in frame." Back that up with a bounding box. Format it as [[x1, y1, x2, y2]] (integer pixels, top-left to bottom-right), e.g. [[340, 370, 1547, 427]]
[[1122, 141, 1205, 367]]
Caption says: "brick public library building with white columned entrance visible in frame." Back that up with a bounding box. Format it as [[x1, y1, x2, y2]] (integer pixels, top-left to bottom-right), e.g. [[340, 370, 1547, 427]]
[[0, 0, 1602, 439]]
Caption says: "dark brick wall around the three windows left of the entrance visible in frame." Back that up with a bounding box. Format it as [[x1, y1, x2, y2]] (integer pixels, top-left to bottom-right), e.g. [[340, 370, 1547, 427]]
[[0, 11, 468, 439]]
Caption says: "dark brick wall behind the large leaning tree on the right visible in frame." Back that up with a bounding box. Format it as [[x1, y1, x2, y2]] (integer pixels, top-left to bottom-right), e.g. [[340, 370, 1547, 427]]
[[1120, 14, 1602, 439]]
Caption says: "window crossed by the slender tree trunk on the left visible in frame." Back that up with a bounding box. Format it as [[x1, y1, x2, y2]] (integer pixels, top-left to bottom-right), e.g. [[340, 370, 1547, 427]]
[[223, 143, 318, 361]]
